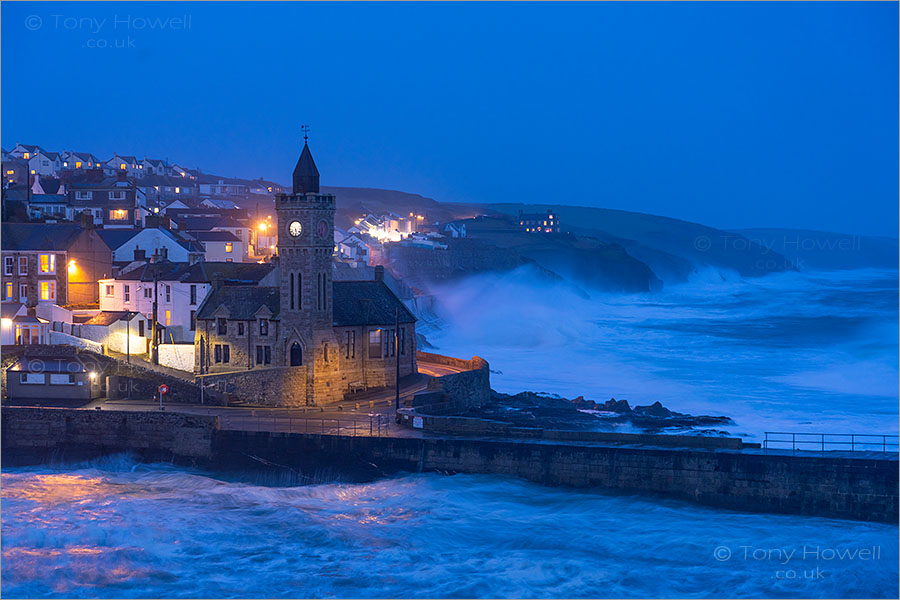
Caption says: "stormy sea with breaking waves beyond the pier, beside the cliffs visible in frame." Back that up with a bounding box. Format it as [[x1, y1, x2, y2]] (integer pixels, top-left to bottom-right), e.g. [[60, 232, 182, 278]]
[[427, 268, 900, 439]]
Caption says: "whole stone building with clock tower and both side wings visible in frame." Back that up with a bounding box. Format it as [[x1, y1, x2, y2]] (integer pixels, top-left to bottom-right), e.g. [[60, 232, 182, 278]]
[[194, 143, 416, 406]]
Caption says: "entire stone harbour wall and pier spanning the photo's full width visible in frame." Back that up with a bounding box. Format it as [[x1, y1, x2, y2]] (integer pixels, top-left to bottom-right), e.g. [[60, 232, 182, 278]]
[[2, 407, 898, 523]]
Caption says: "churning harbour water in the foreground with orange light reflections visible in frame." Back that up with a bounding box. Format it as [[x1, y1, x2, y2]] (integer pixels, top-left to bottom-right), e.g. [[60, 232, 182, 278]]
[[2, 457, 900, 598]]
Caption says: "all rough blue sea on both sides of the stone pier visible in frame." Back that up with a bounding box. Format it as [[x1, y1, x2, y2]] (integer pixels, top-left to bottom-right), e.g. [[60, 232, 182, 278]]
[[0, 270, 900, 598]]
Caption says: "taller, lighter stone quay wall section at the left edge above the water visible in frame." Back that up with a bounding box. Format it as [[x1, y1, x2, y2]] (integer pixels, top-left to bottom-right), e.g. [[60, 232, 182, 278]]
[[2, 407, 218, 463]]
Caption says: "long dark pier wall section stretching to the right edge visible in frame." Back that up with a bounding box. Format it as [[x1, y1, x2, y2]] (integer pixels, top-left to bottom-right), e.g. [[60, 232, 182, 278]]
[[214, 431, 898, 523]]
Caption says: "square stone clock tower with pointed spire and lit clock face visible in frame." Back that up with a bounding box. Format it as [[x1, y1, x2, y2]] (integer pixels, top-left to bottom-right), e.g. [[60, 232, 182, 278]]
[[275, 136, 337, 404]]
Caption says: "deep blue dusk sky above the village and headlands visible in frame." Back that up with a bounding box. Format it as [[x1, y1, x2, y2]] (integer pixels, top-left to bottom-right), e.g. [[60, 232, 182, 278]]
[[2, 2, 898, 236]]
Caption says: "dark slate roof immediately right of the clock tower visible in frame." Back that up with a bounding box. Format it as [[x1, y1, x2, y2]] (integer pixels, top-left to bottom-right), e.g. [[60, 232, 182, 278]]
[[334, 281, 416, 327]]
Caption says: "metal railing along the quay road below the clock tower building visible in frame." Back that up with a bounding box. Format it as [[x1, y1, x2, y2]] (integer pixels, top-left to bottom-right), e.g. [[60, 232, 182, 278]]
[[219, 414, 391, 437]]
